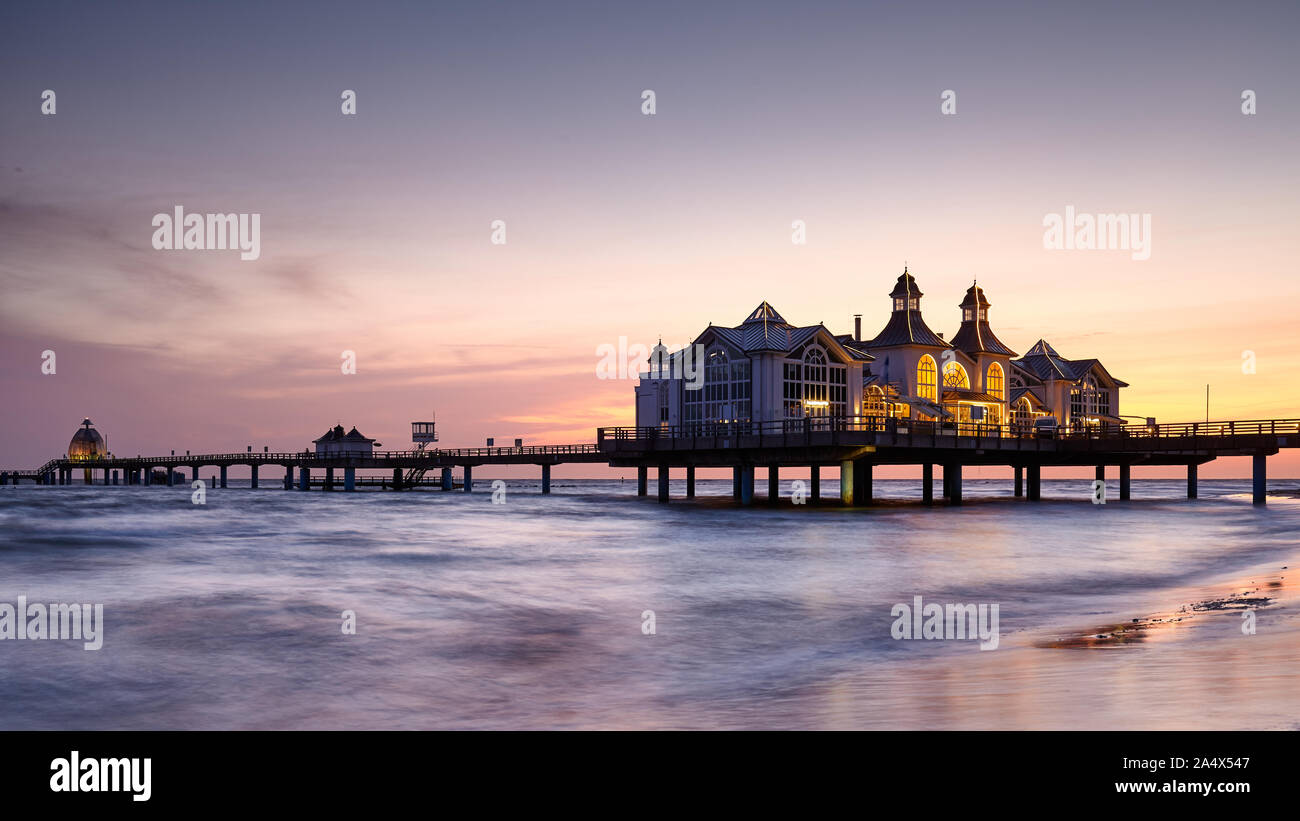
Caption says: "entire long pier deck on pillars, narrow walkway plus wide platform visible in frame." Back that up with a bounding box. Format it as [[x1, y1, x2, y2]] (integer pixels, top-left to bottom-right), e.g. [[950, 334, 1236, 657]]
[[0, 416, 1300, 507]]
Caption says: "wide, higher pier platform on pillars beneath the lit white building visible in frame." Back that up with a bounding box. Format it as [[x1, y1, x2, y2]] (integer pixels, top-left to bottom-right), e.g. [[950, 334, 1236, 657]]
[[597, 416, 1300, 505]]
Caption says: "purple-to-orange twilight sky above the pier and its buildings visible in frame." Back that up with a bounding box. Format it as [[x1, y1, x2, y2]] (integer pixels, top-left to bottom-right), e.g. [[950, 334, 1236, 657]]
[[0, 1, 1300, 477]]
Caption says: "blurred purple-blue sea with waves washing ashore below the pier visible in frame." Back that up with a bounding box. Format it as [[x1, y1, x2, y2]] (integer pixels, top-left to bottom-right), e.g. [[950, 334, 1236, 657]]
[[0, 477, 1300, 730]]
